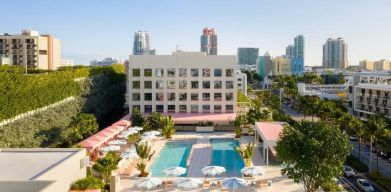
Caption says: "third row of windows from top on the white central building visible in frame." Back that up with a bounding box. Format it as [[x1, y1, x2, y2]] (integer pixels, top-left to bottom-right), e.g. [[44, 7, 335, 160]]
[[132, 93, 234, 101]]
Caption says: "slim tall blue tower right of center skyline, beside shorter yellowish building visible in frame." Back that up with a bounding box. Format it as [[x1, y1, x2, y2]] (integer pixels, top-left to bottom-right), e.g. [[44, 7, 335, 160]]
[[291, 35, 304, 75]]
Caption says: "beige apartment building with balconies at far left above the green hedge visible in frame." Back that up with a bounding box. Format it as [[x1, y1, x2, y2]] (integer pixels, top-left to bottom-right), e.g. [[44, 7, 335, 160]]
[[0, 30, 61, 70]]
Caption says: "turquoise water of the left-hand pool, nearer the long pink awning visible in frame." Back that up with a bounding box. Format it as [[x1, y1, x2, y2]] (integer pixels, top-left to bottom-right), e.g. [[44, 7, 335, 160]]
[[149, 141, 193, 177]]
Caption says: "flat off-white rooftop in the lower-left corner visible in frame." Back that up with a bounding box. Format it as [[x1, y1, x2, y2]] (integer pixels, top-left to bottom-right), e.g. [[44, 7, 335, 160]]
[[0, 148, 80, 181]]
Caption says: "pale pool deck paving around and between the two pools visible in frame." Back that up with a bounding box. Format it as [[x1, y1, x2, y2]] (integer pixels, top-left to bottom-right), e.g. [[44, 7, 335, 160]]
[[118, 132, 304, 192]]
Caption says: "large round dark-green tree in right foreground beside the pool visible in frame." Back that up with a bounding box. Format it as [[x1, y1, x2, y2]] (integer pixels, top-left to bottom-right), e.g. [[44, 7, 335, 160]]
[[276, 121, 351, 192]]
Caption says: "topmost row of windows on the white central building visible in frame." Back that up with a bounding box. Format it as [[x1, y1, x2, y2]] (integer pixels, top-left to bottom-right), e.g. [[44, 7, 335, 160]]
[[132, 68, 234, 77]]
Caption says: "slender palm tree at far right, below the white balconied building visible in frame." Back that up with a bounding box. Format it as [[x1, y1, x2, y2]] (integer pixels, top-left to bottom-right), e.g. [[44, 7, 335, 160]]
[[366, 115, 387, 171]]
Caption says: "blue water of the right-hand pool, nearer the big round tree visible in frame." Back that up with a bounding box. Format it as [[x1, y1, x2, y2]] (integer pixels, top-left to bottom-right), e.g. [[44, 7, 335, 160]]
[[210, 139, 244, 177]]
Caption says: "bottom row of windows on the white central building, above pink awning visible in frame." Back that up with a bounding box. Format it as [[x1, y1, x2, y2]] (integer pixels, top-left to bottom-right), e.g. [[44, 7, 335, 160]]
[[133, 105, 234, 113]]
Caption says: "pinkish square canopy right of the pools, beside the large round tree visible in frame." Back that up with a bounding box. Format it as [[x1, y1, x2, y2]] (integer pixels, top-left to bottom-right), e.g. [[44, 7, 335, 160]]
[[255, 122, 285, 141]]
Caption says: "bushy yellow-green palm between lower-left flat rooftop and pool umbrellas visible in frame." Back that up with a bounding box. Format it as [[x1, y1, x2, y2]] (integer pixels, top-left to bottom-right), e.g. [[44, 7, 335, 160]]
[[92, 153, 121, 184]]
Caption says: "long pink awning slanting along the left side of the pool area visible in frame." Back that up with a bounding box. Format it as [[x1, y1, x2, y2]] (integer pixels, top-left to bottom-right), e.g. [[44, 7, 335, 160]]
[[80, 126, 125, 151]]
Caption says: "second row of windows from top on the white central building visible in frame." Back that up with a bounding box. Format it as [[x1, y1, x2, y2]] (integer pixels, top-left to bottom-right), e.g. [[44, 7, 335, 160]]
[[132, 80, 234, 89]]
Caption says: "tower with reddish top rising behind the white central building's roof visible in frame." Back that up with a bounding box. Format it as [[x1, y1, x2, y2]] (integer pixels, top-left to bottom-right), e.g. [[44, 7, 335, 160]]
[[201, 28, 217, 55]]
